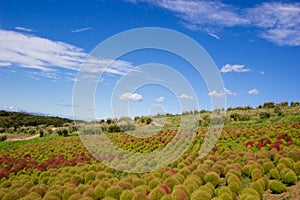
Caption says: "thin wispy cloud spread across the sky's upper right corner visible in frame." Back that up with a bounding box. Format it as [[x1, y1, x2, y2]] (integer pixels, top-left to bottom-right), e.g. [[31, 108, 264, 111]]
[[129, 0, 300, 46]]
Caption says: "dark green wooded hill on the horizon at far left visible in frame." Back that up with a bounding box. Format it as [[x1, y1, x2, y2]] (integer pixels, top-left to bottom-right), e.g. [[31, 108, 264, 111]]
[[0, 110, 72, 128]]
